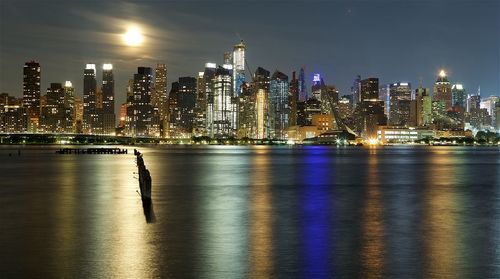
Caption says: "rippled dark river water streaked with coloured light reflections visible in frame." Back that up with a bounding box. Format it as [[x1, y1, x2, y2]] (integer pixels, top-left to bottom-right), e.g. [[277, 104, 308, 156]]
[[0, 146, 500, 278]]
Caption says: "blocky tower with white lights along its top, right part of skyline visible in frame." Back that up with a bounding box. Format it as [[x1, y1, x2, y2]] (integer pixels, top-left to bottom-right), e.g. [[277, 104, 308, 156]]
[[389, 82, 411, 126]]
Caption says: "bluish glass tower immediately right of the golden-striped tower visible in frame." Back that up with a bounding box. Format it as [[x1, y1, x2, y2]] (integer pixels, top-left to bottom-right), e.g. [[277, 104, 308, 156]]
[[268, 71, 290, 139]]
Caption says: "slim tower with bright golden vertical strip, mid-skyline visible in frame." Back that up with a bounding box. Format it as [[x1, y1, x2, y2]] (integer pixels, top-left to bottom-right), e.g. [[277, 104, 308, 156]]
[[253, 67, 270, 139]]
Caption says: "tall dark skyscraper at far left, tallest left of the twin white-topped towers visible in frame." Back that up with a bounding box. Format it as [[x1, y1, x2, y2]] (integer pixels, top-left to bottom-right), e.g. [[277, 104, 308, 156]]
[[23, 61, 41, 132]]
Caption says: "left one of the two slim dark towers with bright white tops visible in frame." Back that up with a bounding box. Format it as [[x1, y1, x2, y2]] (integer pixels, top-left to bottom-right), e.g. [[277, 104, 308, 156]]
[[82, 64, 99, 134]]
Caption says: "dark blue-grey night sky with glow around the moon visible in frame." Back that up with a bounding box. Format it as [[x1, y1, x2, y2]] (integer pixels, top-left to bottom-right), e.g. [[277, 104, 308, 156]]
[[0, 0, 500, 111]]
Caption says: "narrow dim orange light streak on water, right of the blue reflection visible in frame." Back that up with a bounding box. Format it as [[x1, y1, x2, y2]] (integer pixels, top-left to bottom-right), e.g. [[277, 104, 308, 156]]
[[361, 154, 385, 278]]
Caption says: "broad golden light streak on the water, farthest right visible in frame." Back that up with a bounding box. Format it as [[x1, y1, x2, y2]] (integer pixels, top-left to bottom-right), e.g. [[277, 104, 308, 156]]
[[423, 150, 458, 278]]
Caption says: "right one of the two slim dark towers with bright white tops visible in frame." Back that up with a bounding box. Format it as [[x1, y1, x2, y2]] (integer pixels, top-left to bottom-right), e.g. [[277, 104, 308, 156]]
[[101, 64, 116, 135]]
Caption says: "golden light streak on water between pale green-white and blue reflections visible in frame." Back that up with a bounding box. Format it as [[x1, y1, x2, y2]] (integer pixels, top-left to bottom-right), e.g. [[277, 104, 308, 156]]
[[249, 155, 273, 278]]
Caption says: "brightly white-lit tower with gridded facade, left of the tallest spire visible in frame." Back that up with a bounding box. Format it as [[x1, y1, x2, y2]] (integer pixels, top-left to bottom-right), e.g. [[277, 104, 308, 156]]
[[213, 64, 236, 138]]
